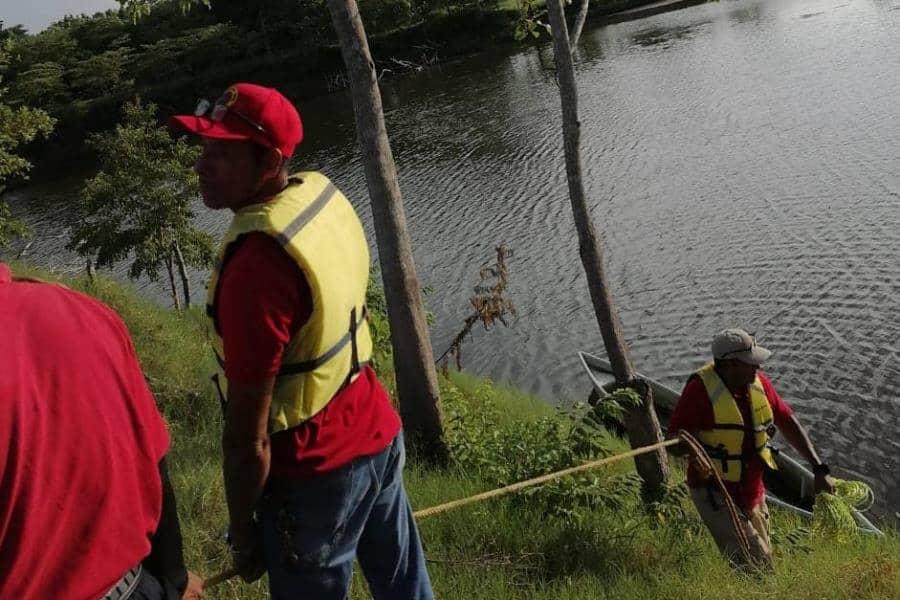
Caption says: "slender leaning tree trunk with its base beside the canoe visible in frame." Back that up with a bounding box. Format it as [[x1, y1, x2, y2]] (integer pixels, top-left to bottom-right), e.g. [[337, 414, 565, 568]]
[[547, 0, 669, 492]]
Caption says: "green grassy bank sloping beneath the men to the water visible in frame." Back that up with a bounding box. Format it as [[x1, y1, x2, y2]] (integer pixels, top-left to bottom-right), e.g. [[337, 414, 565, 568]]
[[13, 265, 900, 599]]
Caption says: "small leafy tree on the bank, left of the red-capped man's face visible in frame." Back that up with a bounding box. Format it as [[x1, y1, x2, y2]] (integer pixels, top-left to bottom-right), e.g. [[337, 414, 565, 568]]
[[69, 100, 213, 308]]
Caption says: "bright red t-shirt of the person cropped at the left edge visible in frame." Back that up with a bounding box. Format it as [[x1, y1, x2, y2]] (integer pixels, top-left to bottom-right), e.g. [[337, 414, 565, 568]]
[[0, 264, 169, 600]]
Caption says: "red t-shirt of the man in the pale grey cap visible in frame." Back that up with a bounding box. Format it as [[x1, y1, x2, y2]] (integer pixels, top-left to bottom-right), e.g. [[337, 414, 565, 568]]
[[669, 371, 793, 510]]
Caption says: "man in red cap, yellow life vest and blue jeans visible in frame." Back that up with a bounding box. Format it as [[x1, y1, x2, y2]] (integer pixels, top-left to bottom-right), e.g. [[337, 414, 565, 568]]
[[170, 83, 433, 600]]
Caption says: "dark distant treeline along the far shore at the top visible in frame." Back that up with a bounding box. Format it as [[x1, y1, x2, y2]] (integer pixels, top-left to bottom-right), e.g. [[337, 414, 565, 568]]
[[0, 0, 517, 177]]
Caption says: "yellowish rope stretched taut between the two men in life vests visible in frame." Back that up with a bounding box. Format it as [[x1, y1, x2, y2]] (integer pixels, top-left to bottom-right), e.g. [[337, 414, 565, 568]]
[[203, 430, 752, 590]]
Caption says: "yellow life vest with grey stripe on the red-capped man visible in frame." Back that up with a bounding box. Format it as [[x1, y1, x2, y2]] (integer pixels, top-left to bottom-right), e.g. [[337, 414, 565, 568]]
[[206, 172, 372, 433]]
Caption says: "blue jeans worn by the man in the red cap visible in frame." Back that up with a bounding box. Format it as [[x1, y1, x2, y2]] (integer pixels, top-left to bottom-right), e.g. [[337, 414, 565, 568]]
[[260, 431, 434, 600]]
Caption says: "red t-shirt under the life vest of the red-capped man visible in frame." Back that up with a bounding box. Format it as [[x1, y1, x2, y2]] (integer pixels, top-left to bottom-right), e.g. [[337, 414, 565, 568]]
[[217, 233, 400, 479]]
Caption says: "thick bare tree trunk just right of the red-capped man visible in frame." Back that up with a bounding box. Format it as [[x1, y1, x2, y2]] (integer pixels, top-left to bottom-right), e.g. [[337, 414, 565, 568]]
[[327, 0, 447, 463]]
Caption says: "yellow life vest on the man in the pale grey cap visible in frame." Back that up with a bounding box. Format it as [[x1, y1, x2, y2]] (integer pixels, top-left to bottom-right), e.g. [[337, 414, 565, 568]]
[[695, 363, 778, 481]]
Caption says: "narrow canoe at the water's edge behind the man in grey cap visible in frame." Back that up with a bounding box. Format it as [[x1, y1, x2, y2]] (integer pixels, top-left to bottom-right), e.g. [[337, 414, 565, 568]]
[[578, 352, 883, 535]]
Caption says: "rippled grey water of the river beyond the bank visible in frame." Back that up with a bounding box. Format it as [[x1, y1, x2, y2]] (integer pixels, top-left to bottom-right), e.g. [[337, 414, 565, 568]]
[[9, 0, 900, 515]]
